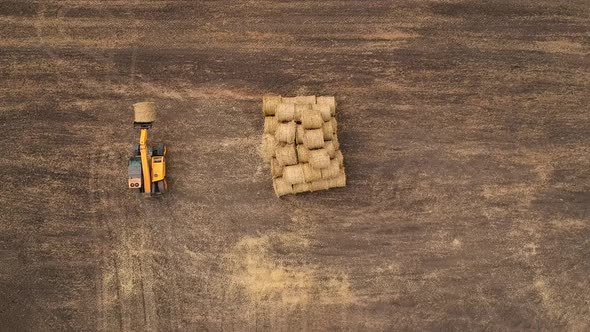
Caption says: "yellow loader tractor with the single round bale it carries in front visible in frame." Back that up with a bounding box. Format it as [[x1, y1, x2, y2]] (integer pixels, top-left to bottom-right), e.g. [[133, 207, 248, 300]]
[[127, 102, 168, 196]]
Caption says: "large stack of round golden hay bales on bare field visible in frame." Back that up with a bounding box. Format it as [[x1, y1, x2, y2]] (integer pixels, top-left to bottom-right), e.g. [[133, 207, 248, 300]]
[[262, 96, 346, 197]]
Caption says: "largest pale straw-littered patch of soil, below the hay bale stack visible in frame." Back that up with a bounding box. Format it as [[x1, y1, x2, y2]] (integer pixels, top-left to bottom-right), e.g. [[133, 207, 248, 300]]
[[229, 234, 354, 309]]
